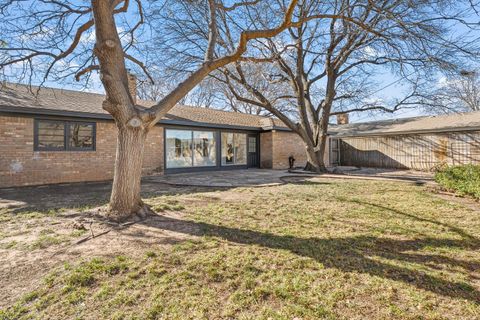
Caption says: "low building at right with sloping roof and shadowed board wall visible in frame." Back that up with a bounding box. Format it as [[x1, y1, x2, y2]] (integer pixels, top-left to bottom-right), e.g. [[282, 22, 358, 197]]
[[329, 112, 480, 171]]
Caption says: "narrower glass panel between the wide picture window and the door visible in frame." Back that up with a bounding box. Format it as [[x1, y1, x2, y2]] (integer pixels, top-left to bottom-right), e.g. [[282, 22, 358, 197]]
[[222, 132, 247, 165]]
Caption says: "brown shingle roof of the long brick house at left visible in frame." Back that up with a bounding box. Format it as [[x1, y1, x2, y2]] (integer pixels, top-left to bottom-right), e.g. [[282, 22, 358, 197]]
[[0, 83, 287, 130]]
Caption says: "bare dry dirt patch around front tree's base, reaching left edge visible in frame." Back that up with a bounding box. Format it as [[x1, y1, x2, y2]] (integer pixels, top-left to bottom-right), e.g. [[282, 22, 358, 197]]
[[0, 206, 197, 307]]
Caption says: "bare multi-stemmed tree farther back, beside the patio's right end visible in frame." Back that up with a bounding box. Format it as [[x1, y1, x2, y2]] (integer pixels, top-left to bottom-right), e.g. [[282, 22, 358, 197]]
[[203, 0, 479, 172]]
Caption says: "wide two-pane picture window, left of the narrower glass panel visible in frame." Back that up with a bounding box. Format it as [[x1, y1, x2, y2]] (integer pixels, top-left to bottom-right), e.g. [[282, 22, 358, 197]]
[[165, 129, 216, 169]]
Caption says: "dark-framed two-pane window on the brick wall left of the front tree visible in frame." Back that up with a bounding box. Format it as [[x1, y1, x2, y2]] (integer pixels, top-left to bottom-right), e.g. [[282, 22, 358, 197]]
[[34, 119, 95, 151]]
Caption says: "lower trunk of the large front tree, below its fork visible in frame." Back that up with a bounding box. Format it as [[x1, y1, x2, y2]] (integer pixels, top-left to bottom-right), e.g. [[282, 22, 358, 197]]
[[107, 125, 148, 220]]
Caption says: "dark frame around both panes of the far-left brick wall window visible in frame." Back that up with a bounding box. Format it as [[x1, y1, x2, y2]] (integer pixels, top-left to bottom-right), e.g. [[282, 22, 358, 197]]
[[33, 118, 97, 152]]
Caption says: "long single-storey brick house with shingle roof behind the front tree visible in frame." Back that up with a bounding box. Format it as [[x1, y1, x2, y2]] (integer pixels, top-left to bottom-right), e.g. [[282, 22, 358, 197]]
[[0, 83, 324, 187]]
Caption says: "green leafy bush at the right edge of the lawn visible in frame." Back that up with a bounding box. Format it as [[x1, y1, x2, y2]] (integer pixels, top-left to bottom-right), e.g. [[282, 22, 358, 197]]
[[435, 164, 480, 199]]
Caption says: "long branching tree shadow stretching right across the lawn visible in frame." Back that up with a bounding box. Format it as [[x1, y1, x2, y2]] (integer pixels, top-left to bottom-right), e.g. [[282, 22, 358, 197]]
[[143, 212, 480, 303]]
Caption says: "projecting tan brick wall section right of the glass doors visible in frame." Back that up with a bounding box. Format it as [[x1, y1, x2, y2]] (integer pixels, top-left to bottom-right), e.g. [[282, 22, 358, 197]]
[[260, 130, 329, 169]]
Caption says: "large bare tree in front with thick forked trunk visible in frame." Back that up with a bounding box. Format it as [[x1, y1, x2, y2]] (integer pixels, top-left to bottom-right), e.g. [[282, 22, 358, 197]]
[[0, 0, 312, 219]]
